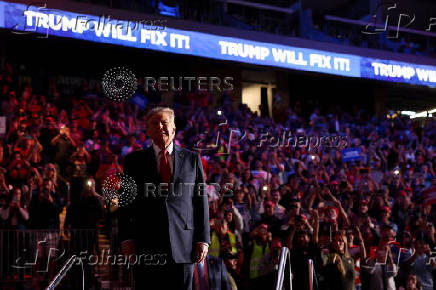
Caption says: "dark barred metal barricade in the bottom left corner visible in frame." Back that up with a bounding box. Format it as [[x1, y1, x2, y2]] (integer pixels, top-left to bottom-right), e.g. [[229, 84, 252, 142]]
[[0, 229, 98, 289]]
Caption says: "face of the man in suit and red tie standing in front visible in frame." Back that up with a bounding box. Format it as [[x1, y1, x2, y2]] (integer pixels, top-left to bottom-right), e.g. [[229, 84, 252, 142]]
[[147, 112, 176, 148]]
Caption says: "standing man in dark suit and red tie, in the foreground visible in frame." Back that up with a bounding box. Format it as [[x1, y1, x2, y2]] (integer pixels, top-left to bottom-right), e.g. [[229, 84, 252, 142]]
[[119, 107, 210, 290]]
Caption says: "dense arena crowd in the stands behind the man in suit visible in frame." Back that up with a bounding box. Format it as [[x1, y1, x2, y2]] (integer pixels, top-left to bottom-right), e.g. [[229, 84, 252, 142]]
[[0, 64, 436, 290]]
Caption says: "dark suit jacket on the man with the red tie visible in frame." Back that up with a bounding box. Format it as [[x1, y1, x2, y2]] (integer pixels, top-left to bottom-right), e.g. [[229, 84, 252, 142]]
[[119, 144, 210, 263]]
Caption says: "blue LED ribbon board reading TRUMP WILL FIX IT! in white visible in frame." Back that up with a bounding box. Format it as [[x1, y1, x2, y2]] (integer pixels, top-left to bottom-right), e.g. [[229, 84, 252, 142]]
[[0, 1, 436, 86]]
